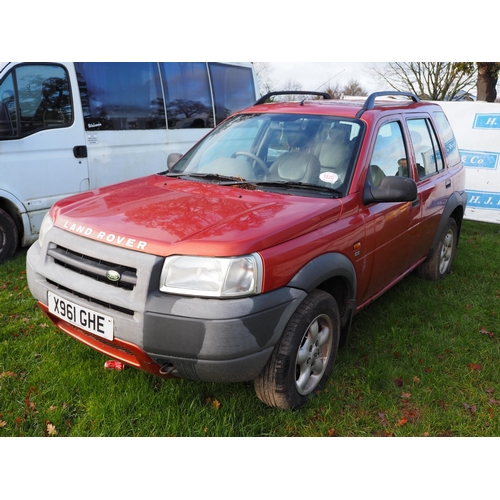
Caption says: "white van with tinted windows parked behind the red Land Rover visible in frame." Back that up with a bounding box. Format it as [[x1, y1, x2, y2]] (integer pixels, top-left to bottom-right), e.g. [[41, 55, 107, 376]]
[[0, 62, 258, 263]]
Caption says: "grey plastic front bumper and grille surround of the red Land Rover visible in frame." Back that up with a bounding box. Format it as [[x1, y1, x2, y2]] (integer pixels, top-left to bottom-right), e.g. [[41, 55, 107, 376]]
[[27, 227, 306, 382]]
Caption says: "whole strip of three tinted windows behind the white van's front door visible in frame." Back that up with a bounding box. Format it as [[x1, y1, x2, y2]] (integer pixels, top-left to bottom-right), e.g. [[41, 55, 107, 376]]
[[75, 62, 255, 130]]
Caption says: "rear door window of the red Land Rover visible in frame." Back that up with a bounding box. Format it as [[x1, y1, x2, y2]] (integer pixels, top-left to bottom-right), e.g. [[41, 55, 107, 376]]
[[407, 118, 444, 179]]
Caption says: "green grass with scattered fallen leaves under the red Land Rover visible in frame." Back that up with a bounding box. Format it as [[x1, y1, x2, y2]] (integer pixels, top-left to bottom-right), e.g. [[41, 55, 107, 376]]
[[0, 221, 500, 437]]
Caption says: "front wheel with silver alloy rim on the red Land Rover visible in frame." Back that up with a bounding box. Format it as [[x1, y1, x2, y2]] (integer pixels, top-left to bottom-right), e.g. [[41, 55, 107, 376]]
[[254, 290, 340, 409]]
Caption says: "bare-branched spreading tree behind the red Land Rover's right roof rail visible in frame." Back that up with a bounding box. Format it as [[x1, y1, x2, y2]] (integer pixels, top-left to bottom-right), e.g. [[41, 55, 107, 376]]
[[372, 62, 476, 101]]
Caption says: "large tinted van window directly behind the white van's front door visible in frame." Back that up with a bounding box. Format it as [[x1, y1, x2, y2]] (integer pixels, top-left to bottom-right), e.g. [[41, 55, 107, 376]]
[[75, 62, 165, 130]]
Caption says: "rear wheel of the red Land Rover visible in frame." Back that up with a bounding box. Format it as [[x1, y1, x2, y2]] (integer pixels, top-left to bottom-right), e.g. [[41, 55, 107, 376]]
[[417, 218, 458, 281]]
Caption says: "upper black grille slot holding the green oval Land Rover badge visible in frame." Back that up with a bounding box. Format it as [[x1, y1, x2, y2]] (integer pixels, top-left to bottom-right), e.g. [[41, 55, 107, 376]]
[[47, 246, 137, 290]]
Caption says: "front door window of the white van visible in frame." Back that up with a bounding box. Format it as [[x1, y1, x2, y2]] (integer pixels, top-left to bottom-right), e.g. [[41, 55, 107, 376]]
[[0, 64, 73, 139]]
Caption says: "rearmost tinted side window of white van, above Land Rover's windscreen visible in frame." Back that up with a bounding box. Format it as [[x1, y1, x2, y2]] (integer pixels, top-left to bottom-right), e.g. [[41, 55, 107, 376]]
[[208, 63, 255, 124]]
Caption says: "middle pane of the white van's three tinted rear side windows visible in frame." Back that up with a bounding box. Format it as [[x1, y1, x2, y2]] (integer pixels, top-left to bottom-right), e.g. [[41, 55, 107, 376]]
[[160, 62, 214, 129]]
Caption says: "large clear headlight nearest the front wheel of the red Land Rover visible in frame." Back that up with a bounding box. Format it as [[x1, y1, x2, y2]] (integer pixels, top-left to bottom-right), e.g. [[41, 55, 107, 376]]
[[160, 254, 262, 297]]
